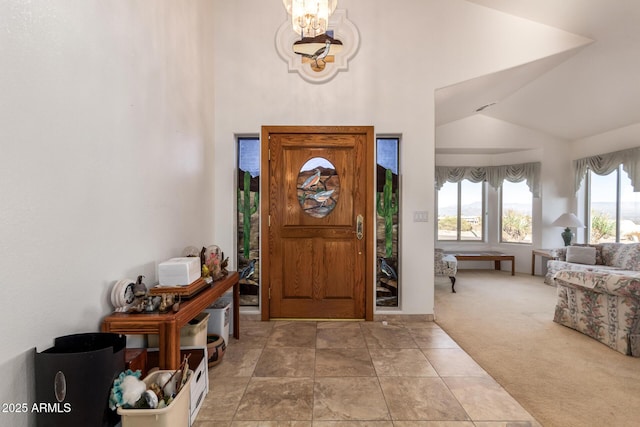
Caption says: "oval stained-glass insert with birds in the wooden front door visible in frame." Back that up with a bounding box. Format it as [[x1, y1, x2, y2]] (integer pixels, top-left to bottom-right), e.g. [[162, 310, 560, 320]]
[[296, 157, 340, 218]]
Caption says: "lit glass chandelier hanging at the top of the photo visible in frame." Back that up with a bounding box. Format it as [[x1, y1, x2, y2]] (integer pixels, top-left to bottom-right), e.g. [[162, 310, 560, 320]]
[[282, 0, 338, 38]]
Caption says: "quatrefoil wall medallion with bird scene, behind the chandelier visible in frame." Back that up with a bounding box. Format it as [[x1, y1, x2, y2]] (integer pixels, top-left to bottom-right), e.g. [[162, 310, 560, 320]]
[[276, 10, 360, 83]]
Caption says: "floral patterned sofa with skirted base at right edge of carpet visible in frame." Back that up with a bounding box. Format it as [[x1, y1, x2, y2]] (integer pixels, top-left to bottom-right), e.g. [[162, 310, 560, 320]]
[[548, 243, 640, 357]]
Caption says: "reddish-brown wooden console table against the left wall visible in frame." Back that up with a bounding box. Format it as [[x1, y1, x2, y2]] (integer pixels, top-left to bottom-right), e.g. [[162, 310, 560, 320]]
[[102, 271, 240, 370]]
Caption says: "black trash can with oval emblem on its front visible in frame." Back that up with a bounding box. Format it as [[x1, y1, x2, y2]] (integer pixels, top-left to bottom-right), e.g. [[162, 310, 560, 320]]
[[35, 333, 127, 427]]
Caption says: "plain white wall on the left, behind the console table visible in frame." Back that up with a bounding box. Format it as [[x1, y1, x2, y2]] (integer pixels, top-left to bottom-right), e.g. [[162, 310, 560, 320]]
[[0, 0, 213, 426]]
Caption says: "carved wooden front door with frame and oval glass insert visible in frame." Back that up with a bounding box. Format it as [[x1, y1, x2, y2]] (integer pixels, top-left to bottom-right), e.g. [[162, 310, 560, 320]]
[[261, 126, 373, 320]]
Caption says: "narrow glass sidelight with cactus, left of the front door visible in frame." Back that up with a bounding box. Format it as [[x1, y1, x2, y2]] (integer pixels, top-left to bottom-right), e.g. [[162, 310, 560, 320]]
[[237, 137, 260, 306]]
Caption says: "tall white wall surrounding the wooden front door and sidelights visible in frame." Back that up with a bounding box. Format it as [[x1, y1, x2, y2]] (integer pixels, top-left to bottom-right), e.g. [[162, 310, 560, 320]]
[[213, 0, 583, 314]]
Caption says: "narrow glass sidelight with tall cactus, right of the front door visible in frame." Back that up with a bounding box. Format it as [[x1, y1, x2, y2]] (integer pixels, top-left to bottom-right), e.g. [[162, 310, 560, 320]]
[[376, 138, 400, 307]]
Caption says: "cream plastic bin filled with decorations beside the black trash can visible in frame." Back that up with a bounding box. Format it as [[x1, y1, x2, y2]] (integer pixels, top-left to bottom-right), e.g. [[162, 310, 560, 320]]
[[118, 370, 193, 427]]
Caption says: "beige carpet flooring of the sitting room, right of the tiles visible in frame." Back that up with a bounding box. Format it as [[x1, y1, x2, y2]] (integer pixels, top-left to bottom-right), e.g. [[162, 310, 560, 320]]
[[435, 270, 640, 427]]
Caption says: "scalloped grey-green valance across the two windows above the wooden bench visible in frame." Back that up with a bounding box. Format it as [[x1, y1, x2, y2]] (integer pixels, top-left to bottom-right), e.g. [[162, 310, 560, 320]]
[[436, 162, 540, 197]]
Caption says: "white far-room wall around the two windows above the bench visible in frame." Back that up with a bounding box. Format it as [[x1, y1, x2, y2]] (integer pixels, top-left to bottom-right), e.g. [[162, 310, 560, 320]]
[[436, 114, 573, 273]]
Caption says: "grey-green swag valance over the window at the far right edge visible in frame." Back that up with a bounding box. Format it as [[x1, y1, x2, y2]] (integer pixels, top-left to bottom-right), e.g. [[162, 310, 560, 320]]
[[573, 147, 640, 192]]
